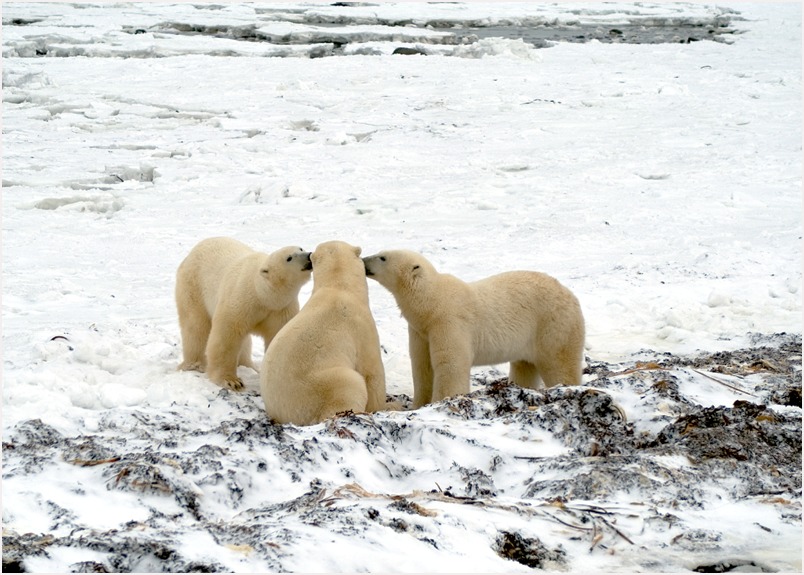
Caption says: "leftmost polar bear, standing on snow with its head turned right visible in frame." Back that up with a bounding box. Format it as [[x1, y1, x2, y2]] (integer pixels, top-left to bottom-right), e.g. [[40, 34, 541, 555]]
[[176, 237, 312, 391]]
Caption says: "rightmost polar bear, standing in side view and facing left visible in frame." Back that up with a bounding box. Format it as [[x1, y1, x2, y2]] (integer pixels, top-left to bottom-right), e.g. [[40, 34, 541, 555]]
[[363, 250, 585, 408]]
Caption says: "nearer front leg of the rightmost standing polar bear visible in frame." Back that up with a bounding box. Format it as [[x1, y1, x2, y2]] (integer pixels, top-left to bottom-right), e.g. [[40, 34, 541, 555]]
[[429, 329, 473, 402]]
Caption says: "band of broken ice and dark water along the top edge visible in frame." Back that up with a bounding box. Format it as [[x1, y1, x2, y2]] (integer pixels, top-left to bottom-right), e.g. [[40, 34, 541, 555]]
[[3, 4, 743, 58]]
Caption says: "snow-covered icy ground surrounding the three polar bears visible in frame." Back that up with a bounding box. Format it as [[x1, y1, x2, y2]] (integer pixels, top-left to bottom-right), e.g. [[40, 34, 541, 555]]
[[2, 3, 802, 572]]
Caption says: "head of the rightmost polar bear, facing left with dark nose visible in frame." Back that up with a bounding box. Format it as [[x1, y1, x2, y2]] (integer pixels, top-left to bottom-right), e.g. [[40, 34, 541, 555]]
[[363, 250, 438, 296]]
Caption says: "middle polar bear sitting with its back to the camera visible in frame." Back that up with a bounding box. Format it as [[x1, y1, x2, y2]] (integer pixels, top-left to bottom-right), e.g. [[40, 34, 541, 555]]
[[260, 241, 386, 425]]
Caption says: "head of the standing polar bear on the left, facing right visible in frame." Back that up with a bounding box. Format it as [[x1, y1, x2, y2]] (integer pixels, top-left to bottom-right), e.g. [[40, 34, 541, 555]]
[[255, 246, 313, 309]]
